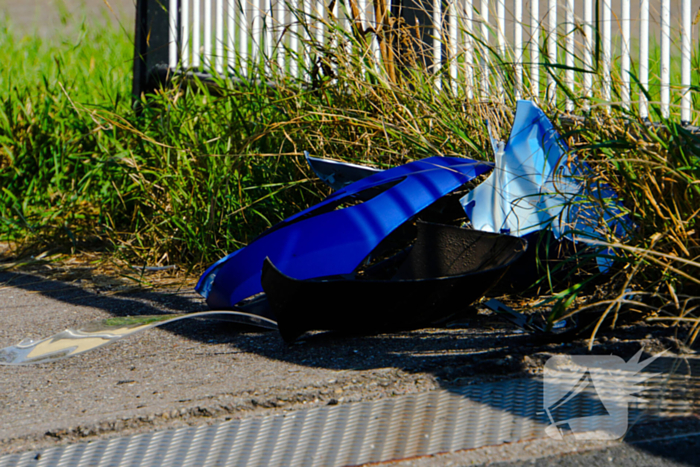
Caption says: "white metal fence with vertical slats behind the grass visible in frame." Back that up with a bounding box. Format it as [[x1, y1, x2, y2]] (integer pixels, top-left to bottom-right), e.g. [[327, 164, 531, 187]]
[[162, 0, 700, 123]]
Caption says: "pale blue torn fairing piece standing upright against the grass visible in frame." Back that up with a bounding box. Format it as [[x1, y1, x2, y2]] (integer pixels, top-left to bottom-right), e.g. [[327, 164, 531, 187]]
[[461, 101, 630, 268]]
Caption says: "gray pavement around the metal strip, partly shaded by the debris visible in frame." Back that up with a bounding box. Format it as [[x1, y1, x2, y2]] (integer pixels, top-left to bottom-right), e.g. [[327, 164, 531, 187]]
[[0, 272, 700, 466]]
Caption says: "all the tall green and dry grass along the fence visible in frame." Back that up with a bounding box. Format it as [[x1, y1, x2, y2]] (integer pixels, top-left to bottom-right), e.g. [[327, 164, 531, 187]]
[[0, 8, 700, 344]]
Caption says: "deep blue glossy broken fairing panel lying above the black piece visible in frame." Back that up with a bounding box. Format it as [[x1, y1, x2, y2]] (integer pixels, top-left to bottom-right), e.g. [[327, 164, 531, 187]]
[[195, 157, 493, 308]]
